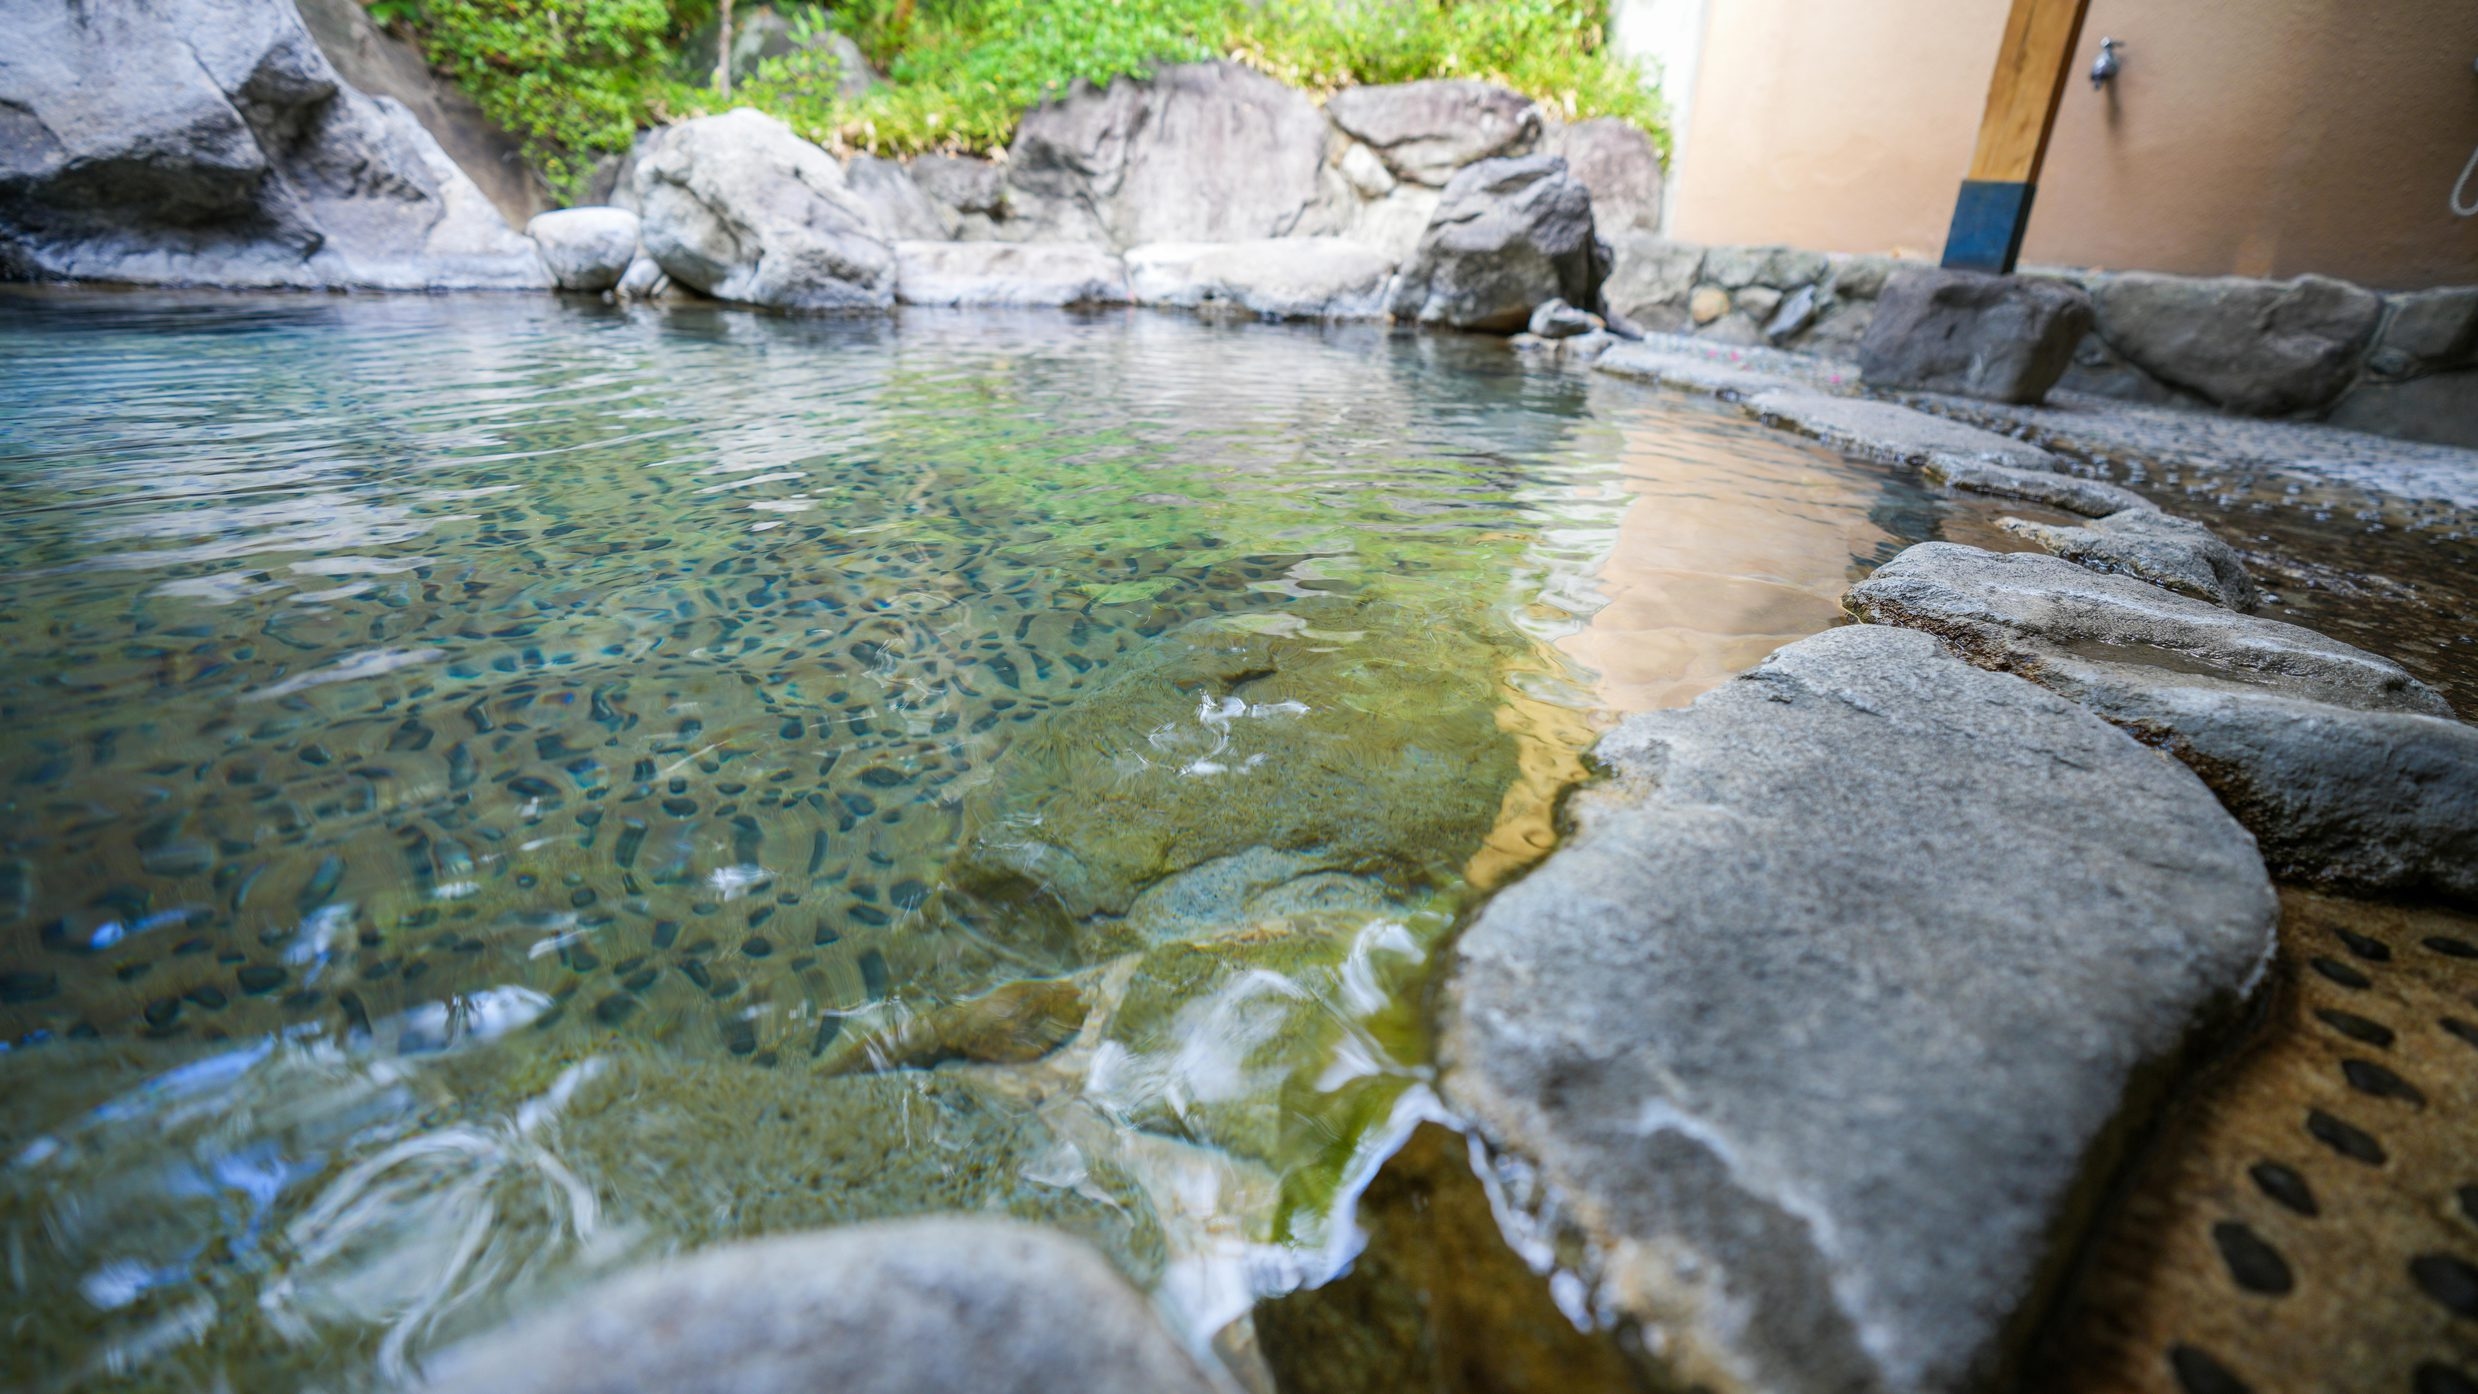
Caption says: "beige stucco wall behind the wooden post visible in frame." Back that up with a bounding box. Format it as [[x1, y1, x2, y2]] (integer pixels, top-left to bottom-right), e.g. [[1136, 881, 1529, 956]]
[[1670, 0, 2478, 287]]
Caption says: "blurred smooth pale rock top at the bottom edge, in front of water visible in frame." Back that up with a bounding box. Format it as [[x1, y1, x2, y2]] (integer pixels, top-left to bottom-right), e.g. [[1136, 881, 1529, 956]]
[[424, 1216, 1212, 1394]]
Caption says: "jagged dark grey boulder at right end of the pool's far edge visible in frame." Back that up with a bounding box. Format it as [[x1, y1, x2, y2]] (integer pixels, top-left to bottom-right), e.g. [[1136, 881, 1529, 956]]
[[1393, 156, 1608, 334]]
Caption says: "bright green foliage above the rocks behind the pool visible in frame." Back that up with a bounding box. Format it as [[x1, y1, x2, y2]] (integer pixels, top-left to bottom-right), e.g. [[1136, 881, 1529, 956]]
[[379, 0, 1668, 191]]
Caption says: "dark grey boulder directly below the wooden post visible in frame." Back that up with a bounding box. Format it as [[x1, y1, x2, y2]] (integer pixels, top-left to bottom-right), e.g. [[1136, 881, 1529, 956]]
[[1859, 267, 2091, 406]]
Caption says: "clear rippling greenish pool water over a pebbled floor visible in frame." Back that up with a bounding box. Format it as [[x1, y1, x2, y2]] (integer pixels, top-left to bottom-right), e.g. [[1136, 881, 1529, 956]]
[[0, 292, 1940, 1389]]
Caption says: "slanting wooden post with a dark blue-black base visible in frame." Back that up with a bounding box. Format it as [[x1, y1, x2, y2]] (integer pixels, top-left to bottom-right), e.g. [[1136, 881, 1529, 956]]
[[1945, 0, 2089, 275]]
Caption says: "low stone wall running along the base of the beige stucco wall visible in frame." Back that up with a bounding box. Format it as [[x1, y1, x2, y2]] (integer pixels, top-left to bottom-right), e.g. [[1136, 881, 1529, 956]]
[[1606, 230, 2478, 446]]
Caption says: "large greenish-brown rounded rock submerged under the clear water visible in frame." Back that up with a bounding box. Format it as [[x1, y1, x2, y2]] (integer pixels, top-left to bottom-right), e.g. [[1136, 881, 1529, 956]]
[[947, 612, 1514, 966]]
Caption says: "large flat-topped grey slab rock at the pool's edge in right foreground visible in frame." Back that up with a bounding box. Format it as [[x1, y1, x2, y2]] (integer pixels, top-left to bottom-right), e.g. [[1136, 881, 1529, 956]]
[[1442, 626, 2275, 1394]]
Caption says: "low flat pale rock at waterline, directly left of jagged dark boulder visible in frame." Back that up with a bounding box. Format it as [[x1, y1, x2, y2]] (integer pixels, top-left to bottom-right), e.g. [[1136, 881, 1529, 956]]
[[1127, 238, 1393, 319]]
